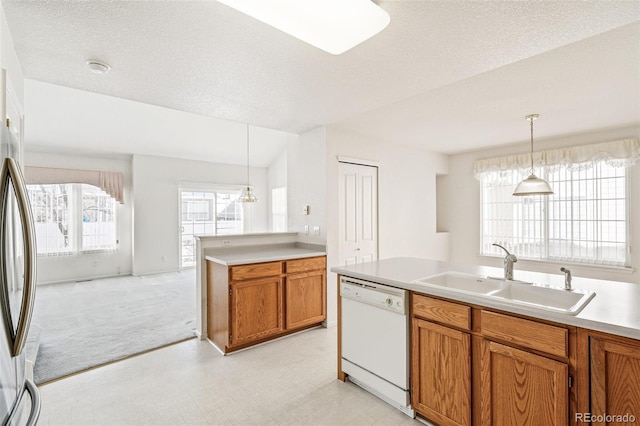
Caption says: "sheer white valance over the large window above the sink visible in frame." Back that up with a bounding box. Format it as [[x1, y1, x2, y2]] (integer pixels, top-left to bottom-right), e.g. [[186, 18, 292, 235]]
[[473, 139, 640, 179]]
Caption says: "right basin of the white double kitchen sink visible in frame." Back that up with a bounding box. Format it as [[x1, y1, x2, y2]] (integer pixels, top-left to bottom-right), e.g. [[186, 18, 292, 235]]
[[491, 282, 596, 315]]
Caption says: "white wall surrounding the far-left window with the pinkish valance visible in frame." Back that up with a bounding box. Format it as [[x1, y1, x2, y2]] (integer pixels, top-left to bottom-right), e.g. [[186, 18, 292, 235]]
[[25, 150, 133, 284]]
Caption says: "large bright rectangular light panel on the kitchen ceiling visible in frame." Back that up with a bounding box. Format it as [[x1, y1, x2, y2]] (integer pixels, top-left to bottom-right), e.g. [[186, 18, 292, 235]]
[[218, 0, 391, 55]]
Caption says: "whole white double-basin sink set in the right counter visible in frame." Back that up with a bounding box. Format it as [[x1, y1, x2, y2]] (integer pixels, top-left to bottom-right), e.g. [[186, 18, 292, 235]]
[[414, 272, 596, 315]]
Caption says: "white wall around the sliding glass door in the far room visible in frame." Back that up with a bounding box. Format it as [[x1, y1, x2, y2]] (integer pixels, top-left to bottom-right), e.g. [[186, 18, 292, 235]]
[[132, 155, 269, 275]]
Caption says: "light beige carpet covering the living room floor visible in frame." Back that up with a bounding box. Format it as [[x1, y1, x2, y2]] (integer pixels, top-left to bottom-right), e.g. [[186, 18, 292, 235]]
[[32, 269, 196, 384]]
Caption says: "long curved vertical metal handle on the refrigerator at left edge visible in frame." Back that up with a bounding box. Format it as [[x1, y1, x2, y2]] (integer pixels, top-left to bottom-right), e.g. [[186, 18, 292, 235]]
[[0, 158, 36, 356]]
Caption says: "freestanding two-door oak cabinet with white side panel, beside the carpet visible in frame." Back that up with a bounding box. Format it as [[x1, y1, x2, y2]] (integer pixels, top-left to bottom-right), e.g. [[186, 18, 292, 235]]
[[207, 256, 326, 353]]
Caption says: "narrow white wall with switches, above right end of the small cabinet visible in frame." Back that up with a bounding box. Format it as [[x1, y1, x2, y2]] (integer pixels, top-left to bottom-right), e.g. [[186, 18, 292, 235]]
[[287, 127, 328, 245]]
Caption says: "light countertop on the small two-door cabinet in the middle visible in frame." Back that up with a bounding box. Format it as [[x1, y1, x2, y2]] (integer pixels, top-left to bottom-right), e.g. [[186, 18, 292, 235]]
[[204, 243, 327, 266]]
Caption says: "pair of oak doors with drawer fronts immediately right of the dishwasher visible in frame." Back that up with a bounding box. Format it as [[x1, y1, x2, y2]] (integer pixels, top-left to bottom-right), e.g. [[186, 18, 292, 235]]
[[411, 293, 576, 426]]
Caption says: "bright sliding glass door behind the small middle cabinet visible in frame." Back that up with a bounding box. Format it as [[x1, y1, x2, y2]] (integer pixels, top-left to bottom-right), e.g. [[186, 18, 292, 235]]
[[180, 189, 243, 267]]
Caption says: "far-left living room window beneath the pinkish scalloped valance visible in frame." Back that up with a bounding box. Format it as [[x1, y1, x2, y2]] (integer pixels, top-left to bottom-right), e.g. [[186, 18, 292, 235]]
[[27, 184, 118, 255]]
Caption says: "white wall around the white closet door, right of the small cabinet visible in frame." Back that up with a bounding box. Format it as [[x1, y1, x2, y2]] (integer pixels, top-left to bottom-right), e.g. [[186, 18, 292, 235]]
[[326, 126, 448, 323]]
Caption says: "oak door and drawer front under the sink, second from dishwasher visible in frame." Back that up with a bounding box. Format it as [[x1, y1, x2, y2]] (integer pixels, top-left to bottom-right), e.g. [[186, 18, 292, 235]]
[[478, 310, 569, 426]]
